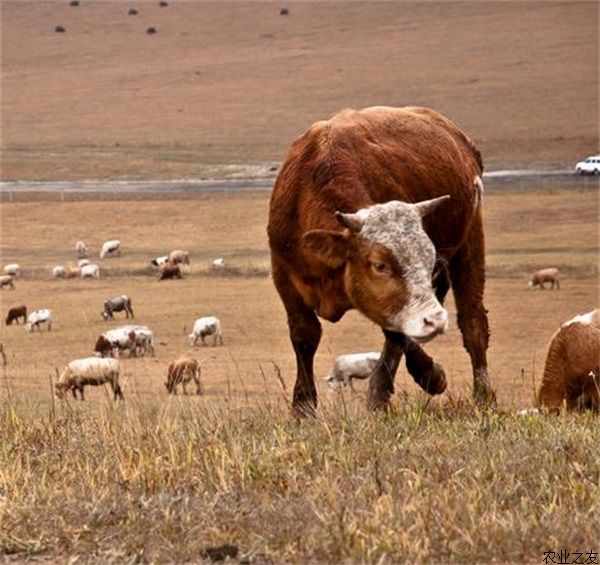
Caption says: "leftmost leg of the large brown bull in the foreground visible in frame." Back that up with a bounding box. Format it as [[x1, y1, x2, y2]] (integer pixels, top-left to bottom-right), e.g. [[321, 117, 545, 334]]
[[273, 268, 321, 417]]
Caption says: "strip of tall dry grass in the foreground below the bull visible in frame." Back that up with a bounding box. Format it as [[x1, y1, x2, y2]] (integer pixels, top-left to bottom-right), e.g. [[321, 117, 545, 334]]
[[0, 388, 600, 563]]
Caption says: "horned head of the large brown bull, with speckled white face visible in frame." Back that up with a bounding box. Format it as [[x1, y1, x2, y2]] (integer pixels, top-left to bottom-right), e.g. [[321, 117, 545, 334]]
[[303, 196, 449, 341]]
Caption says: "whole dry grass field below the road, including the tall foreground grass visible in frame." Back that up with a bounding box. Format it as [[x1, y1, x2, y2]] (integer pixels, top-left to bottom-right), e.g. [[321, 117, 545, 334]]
[[0, 187, 600, 563]]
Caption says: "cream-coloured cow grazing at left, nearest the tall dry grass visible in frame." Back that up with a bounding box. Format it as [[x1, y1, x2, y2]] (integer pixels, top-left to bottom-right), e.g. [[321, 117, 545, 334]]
[[55, 357, 123, 400]]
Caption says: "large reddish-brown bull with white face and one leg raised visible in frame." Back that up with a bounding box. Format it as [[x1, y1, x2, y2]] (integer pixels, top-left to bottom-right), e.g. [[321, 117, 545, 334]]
[[267, 107, 495, 415]]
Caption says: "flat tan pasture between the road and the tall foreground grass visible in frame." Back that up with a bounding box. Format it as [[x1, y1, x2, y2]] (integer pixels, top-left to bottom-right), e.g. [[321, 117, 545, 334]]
[[0, 185, 598, 410]]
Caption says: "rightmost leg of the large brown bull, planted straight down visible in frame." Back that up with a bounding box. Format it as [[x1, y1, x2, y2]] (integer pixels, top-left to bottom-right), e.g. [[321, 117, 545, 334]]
[[450, 214, 496, 404]]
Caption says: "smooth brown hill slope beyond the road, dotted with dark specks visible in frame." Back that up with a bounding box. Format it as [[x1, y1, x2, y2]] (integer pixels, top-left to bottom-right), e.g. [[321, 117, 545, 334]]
[[0, 0, 599, 179]]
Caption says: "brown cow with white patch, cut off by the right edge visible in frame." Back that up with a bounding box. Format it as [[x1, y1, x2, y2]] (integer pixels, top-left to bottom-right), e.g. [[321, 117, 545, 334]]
[[538, 309, 600, 412]]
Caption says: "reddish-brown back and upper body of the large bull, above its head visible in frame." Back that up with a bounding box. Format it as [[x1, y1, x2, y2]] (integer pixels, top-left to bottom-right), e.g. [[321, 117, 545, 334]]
[[268, 107, 483, 262]]
